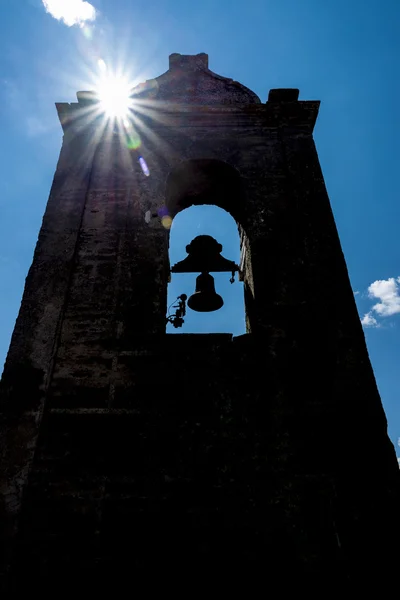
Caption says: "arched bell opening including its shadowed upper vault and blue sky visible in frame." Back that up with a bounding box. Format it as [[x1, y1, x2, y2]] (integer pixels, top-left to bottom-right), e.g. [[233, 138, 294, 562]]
[[165, 159, 246, 335]]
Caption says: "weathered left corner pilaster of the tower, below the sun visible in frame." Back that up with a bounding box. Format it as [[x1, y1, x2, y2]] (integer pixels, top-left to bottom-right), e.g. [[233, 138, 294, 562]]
[[0, 125, 96, 576]]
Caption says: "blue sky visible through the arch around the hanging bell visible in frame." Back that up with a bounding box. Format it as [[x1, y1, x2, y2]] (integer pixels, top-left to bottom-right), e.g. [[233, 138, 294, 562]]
[[167, 206, 246, 335]]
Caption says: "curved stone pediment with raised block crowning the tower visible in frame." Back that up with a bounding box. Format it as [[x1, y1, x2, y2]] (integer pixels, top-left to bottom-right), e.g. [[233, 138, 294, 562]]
[[133, 54, 260, 105]]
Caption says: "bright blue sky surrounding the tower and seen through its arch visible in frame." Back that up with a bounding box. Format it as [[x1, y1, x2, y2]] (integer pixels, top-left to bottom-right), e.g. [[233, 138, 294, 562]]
[[0, 0, 400, 456]]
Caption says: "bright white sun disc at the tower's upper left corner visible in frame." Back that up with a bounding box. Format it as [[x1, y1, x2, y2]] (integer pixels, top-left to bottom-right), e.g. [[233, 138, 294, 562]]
[[97, 74, 132, 119]]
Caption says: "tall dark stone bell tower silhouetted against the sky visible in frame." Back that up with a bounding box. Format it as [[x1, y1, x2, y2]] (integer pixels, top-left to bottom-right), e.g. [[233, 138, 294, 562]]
[[0, 54, 400, 597]]
